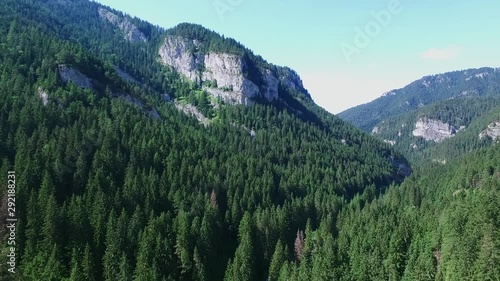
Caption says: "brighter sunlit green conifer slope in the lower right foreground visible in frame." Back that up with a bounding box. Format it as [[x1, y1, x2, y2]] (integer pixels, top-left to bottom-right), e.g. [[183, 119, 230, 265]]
[[271, 144, 500, 281]]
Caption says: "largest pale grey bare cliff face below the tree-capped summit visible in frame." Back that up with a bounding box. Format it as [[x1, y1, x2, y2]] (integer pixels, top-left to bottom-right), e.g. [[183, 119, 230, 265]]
[[159, 35, 307, 104]]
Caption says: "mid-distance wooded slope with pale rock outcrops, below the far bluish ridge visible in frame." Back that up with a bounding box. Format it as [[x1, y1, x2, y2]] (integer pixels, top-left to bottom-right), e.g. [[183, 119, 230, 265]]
[[372, 97, 500, 163]]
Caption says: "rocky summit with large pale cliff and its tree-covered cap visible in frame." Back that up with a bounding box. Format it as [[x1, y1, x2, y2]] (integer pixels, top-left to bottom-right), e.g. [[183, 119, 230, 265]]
[[159, 23, 310, 104]]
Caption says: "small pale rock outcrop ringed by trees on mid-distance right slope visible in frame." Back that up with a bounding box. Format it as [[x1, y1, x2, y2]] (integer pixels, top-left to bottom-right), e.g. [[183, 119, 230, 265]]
[[412, 118, 457, 142]]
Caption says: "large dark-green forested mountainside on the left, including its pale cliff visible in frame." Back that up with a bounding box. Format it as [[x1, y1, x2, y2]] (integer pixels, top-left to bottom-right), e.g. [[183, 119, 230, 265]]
[[0, 0, 414, 281]]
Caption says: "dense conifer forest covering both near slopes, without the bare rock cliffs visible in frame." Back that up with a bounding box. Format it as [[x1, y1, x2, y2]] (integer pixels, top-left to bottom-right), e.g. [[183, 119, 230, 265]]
[[0, 0, 500, 281]]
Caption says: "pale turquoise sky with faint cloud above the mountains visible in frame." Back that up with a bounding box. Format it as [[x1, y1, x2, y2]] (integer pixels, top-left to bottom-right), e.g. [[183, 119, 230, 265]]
[[97, 0, 500, 113]]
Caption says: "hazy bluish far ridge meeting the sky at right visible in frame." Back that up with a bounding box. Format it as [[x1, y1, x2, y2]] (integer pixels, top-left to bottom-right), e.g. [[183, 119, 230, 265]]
[[338, 67, 500, 132]]
